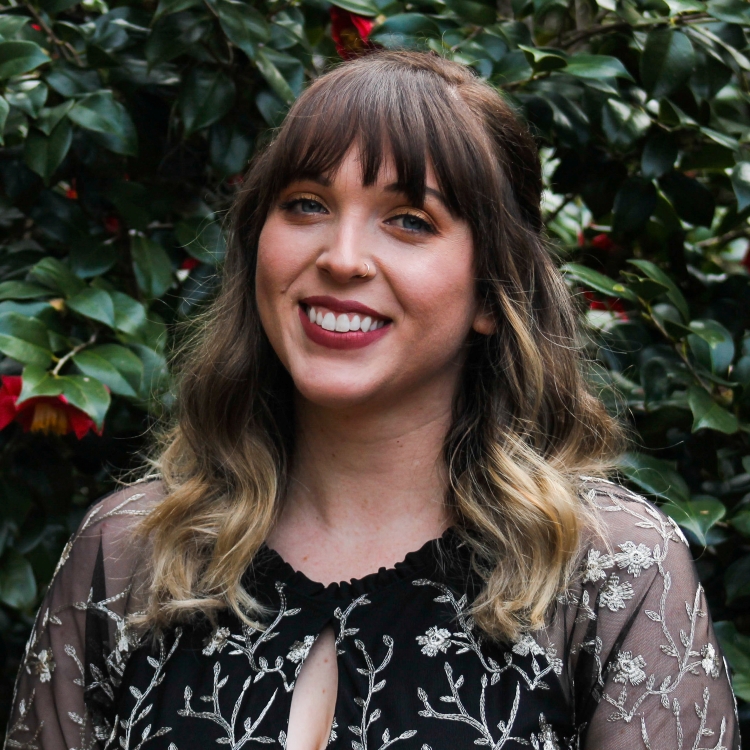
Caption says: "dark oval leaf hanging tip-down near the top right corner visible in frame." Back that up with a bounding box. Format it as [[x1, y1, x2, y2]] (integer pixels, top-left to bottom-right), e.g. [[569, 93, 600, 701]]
[[641, 28, 695, 99]]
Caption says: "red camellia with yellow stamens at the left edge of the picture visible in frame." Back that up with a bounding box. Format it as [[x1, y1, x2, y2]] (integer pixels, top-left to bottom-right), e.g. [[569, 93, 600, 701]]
[[0, 375, 102, 440]]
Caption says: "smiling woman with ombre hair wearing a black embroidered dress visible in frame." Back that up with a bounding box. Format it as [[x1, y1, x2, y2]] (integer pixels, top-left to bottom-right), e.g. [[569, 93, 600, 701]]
[[1, 52, 739, 750]]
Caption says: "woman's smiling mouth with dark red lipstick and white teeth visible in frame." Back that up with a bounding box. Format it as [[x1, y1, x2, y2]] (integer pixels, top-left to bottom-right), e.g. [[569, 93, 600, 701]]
[[299, 301, 391, 349]]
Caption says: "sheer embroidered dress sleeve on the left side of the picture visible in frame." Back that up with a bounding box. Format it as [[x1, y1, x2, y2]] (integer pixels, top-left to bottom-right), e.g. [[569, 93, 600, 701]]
[[5, 482, 161, 750]]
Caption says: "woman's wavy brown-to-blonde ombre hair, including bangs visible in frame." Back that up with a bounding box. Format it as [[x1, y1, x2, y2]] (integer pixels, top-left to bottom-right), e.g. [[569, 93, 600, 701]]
[[141, 51, 621, 639]]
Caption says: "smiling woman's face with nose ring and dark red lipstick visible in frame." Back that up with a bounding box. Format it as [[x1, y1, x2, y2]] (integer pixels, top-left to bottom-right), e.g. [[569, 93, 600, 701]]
[[256, 149, 491, 414]]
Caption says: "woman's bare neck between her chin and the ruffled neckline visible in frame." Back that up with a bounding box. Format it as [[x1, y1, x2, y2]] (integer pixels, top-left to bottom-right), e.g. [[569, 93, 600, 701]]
[[268, 394, 458, 583]]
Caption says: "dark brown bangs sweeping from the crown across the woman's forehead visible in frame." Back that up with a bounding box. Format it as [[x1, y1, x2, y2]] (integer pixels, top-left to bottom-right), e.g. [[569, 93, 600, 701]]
[[268, 53, 495, 218]]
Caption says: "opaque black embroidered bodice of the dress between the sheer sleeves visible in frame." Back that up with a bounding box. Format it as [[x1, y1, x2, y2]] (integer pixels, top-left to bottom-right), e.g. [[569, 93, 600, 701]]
[[110, 581, 573, 750]]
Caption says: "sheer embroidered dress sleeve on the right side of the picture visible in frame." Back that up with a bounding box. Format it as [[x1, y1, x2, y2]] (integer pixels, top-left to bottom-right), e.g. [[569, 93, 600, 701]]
[[567, 482, 740, 750]]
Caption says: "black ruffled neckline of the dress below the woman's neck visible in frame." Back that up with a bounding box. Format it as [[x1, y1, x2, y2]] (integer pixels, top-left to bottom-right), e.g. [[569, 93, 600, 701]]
[[252, 526, 464, 601]]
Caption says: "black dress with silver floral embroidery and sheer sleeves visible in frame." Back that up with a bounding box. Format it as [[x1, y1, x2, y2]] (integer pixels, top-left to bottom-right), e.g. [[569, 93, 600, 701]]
[[2, 480, 740, 750]]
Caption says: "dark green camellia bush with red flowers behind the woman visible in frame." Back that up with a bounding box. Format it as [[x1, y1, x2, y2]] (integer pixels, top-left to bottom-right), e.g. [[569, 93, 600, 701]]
[[0, 0, 750, 736]]
